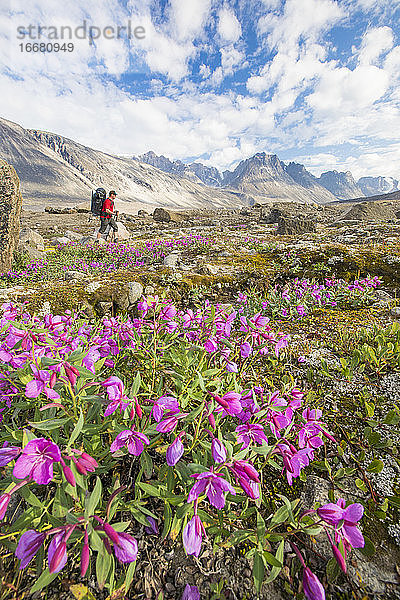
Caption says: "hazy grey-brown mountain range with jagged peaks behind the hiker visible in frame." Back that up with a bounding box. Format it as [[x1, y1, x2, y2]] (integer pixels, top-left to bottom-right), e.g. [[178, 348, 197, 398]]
[[0, 118, 399, 213]]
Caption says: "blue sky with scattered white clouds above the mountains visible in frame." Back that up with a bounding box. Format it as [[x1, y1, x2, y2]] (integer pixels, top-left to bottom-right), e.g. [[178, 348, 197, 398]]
[[0, 0, 400, 178]]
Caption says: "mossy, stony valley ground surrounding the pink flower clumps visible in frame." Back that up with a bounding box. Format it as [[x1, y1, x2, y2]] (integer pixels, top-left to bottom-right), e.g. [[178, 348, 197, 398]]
[[0, 200, 400, 600]]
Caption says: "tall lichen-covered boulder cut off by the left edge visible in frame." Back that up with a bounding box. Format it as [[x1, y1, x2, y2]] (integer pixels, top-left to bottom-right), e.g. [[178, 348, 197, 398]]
[[0, 159, 22, 272]]
